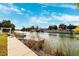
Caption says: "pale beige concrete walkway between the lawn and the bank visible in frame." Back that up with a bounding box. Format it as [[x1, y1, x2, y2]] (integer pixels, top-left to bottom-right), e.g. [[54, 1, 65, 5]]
[[8, 37, 37, 56]]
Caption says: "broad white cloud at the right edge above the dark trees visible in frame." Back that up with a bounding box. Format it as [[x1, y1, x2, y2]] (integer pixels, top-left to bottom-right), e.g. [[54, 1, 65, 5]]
[[50, 14, 79, 25]]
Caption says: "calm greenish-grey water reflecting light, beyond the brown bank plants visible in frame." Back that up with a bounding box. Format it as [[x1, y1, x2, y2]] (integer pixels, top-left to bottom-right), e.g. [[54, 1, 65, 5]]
[[31, 32, 79, 56]]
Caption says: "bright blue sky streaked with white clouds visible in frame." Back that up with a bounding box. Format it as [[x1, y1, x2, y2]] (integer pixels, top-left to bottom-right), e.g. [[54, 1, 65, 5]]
[[0, 3, 79, 29]]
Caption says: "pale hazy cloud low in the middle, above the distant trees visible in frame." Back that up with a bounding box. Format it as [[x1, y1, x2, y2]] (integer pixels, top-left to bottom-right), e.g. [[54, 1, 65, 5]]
[[27, 16, 58, 28]]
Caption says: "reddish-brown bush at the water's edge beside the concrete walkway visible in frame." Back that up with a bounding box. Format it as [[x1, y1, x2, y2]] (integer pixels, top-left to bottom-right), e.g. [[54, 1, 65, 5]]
[[21, 40, 44, 51]]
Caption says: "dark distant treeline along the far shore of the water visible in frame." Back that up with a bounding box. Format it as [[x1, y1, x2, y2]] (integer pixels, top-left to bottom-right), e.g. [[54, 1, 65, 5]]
[[21, 24, 77, 31]]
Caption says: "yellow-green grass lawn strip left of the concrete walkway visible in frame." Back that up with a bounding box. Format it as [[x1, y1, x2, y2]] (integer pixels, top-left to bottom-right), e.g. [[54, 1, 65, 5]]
[[0, 33, 7, 56]]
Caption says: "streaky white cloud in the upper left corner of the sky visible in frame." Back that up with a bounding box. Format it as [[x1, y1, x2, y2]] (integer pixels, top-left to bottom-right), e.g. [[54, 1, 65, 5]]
[[0, 4, 24, 14]]
